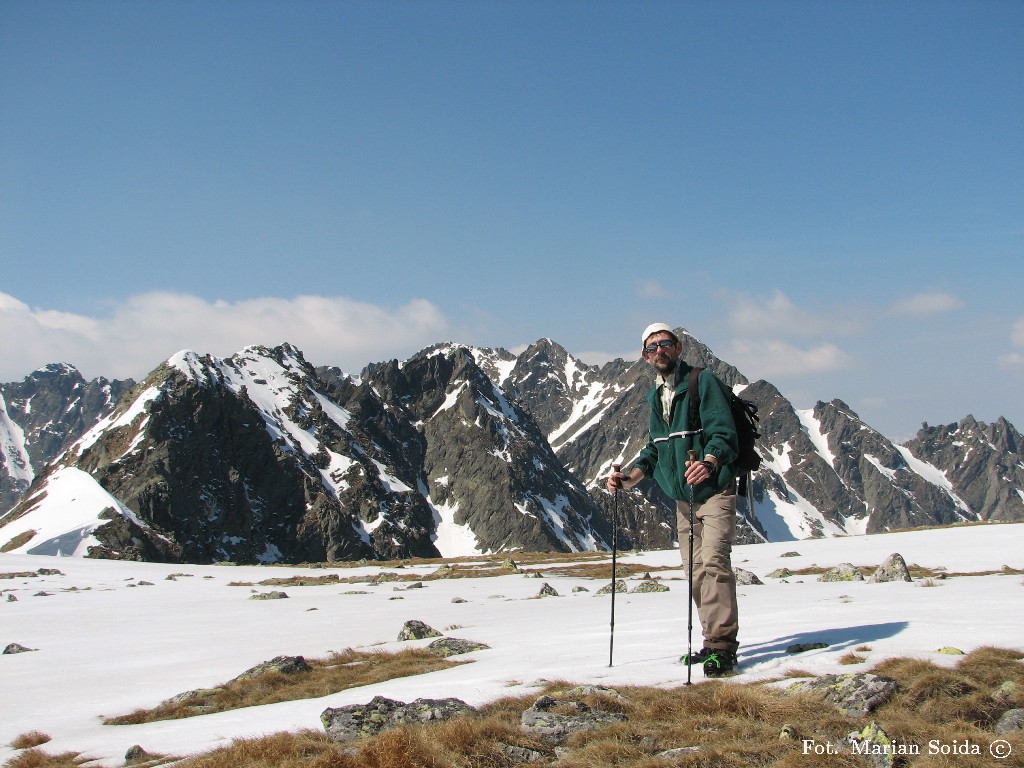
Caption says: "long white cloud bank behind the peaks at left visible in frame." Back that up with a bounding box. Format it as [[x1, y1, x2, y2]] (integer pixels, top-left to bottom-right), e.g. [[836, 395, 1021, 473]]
[[0, 292, 451, 381]]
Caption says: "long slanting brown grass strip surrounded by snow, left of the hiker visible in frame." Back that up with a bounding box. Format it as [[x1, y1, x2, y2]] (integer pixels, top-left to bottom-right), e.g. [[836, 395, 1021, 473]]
[[103, 648, 468, 725]]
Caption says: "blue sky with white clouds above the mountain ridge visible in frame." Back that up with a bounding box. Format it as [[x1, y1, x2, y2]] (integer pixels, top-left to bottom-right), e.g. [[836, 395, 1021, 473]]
[[0, 0, 1024, 438]]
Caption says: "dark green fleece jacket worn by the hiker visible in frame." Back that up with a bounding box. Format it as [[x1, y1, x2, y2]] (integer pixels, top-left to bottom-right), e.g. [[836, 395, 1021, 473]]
[[636, 360, 737, 503]]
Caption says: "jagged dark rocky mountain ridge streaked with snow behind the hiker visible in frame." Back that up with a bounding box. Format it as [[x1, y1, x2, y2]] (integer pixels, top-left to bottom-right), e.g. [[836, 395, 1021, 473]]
[[0, 329, 1024, 562]]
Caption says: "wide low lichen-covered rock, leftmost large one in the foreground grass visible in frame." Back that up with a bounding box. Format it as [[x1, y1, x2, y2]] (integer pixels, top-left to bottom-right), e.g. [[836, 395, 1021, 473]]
[[321, 696, 476, 743]]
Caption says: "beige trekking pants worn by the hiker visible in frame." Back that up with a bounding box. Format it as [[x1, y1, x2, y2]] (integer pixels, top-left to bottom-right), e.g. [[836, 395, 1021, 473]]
[[676, 492, 739, 652]]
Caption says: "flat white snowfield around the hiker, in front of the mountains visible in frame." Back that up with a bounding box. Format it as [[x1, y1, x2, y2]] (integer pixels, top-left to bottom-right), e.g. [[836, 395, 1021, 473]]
[[0, 524, 1024, 766]]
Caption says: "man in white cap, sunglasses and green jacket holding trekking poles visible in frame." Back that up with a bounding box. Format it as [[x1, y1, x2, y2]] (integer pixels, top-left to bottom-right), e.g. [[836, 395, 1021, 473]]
[[607, 323, 739, 677]]
